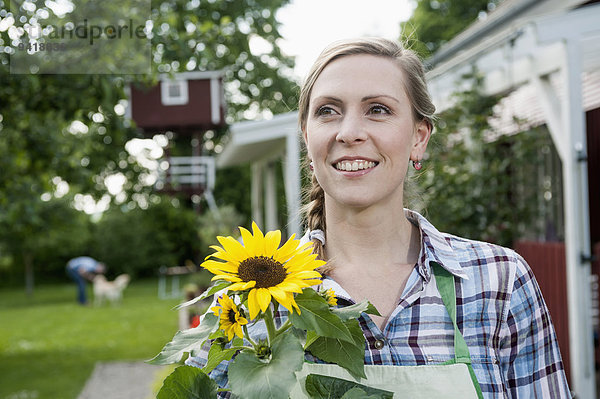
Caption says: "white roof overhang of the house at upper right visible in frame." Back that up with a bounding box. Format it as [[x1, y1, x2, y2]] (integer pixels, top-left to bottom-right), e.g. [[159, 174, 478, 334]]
[[427, 0, 600, 112]]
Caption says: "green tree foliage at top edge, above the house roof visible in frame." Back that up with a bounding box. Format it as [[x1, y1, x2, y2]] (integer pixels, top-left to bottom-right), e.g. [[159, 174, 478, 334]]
[[400, 0, 502, 58]]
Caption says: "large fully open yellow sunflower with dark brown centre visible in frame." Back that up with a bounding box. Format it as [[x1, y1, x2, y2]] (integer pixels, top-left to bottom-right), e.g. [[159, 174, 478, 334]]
[[201, 223, 325, 319]]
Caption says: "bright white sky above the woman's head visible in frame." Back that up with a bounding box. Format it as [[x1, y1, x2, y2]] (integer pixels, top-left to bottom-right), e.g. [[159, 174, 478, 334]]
[[276, 0, 415, 79]]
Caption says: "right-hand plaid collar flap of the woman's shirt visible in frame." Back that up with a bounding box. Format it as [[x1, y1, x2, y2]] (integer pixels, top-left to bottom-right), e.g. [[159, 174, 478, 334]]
[[404, 209, 469, 282]]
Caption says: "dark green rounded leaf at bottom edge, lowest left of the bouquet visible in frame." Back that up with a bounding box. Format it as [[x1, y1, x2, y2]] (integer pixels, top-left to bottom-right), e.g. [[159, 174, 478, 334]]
[[156, 366, 218, 399]]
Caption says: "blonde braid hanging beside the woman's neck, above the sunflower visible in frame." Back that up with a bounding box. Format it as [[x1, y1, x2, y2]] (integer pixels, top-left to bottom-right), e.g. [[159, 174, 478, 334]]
[[302, 169, 331, 275]]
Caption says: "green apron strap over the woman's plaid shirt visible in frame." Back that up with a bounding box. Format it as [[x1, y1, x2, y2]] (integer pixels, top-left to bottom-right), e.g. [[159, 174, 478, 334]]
[[429, 262, 483, 398]]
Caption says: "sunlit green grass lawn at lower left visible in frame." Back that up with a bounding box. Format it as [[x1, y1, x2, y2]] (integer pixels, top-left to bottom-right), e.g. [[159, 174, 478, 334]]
[[0, 280, 181, 399]]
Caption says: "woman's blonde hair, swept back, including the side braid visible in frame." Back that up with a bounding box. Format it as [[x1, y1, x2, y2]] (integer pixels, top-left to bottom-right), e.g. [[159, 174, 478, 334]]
[[298, 38, 435, 274]]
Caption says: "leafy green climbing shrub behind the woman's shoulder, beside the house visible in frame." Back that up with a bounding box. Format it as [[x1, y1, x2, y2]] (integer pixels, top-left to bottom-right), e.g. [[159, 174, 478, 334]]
[[418, 74, 552, 246]]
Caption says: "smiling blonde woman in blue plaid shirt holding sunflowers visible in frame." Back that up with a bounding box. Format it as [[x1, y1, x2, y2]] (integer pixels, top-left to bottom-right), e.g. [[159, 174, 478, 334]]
[[190, 39, 570, 398]]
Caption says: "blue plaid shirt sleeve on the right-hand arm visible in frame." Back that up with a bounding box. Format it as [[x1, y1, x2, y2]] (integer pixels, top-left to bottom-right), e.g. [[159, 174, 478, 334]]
[[499, 254, 571, 398]]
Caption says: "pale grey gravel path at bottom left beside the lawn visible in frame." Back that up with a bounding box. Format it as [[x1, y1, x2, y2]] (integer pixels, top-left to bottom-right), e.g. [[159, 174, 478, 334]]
[[77, 362, 163, 399]]
